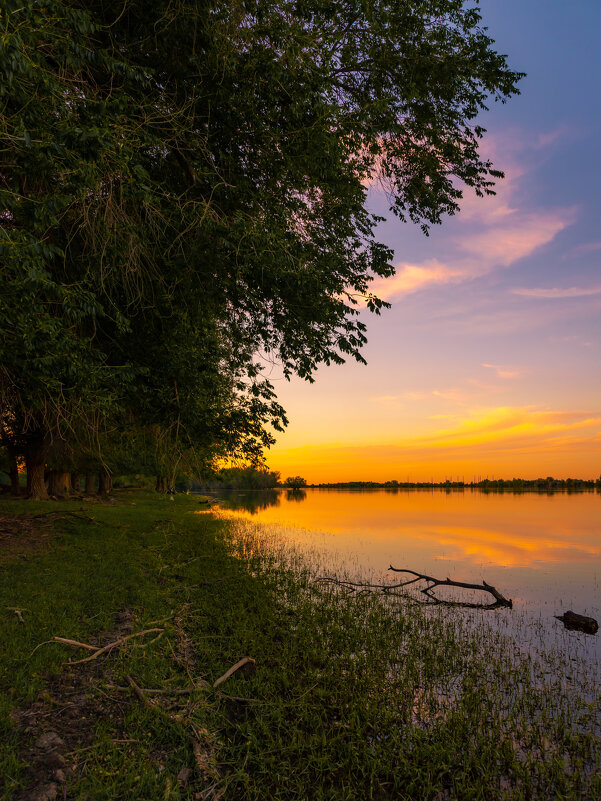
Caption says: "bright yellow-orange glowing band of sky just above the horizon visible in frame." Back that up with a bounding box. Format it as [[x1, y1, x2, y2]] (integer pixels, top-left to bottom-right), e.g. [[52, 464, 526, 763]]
[[268, 407, 601, 483]]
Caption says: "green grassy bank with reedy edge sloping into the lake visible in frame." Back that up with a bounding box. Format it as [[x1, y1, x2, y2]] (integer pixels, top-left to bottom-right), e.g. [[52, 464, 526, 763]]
[[0, 494, 601, 801]]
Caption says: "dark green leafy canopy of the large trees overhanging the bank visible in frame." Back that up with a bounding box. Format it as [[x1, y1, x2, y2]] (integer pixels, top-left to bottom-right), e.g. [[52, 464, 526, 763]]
[[0, 0, 520, 495]]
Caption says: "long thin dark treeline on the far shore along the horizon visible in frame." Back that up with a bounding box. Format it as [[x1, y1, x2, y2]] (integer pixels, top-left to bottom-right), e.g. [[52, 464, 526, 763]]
[[308, 476, 601, 492]]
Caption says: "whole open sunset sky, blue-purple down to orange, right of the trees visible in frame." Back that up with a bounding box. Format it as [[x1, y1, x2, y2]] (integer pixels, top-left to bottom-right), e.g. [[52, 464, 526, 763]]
[[267, 0, 601, 483]]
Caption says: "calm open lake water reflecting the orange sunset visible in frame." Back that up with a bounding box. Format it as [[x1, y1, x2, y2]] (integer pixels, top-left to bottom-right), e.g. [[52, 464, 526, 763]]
[[211, 489, 601, 661]]
